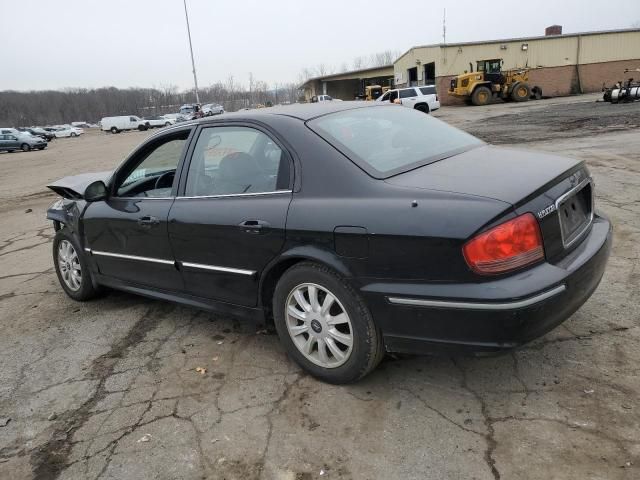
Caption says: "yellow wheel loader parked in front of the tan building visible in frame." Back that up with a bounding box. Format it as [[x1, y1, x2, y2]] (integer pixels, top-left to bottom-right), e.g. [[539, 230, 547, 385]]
[[449, 59, 542, 105]]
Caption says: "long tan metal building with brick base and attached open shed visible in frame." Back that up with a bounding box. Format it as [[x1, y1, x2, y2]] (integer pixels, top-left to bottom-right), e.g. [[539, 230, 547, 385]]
[[303, 25, 640, 105]]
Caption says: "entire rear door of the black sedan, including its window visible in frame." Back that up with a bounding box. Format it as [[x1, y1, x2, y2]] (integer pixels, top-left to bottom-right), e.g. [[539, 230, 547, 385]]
[[169, 124, 292, 306]]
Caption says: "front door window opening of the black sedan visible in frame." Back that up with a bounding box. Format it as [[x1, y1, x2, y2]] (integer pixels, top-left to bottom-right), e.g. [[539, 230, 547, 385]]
[[116, 131, 189, 198]]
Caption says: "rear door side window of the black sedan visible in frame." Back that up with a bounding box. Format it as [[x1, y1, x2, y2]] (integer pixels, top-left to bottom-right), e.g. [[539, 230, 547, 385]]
[[185, 126, 289, 197]]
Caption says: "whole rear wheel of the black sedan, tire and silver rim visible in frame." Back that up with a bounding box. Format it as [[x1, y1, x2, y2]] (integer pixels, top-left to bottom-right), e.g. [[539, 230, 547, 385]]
[[273, 262, 384, 384]]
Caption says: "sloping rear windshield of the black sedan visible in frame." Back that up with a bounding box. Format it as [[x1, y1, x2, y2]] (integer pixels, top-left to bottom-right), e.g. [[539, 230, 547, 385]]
[[308, 105, 483, 178]]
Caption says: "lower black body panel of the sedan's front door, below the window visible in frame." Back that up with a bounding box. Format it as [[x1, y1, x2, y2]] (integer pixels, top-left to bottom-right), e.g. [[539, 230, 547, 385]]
[[84, 198, 183, 291]]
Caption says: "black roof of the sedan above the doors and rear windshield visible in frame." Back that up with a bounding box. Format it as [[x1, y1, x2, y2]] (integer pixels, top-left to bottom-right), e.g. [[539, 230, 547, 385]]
[[191, 101, 389, 123]]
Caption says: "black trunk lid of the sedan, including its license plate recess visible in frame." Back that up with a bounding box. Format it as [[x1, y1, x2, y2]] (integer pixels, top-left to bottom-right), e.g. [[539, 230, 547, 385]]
[[386, 146, 594, 263]]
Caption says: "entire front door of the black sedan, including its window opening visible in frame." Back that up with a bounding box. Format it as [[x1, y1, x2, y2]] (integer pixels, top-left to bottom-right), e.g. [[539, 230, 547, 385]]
[[83, 129, 191, 291]]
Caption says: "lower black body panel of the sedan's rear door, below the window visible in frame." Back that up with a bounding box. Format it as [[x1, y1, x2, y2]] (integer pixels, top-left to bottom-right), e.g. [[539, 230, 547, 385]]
[[169, 192, 291, 306]]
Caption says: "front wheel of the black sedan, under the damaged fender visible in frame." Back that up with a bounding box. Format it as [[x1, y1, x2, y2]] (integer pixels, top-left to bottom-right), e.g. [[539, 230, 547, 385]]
[[53, 228, 98, 301]]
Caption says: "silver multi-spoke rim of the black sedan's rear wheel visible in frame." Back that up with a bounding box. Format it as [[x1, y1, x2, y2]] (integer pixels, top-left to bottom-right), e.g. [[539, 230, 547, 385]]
[[285, 283, 353, 368]]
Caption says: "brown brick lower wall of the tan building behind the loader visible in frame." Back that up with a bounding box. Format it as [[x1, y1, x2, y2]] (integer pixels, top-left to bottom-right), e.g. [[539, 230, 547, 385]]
[[436, 59, 640, 105]]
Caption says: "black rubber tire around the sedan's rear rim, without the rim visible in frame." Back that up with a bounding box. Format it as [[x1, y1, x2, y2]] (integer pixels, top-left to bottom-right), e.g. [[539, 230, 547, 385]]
[[273, 262, 384, 384]]
